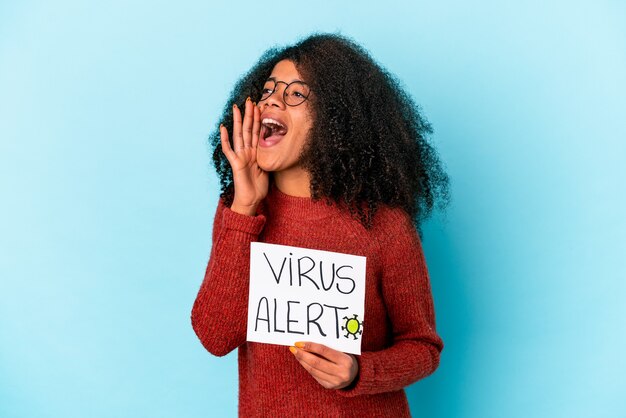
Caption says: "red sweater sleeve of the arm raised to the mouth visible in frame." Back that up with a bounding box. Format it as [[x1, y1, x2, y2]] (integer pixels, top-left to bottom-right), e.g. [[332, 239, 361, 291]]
[[191, 198, 265, 356]]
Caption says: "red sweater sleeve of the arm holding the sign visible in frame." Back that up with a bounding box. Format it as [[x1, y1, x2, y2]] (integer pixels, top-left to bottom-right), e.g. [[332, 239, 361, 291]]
[[337, 210, 443, 397]]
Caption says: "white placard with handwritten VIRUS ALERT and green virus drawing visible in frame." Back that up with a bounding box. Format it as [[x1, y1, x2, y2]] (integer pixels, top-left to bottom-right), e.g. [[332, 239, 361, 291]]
[[247, 242, 366, 354]]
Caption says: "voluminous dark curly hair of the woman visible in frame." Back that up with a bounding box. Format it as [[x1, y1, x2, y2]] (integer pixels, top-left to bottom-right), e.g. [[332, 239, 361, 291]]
[[209, 33, 450, 236]]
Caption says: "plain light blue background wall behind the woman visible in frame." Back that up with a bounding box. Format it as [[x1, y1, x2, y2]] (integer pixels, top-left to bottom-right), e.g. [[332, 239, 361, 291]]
[[0, 0, 626, 418]]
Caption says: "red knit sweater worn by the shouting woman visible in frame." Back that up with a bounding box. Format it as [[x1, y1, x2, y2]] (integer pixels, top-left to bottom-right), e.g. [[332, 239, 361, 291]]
[[191, 183, 443, 418]]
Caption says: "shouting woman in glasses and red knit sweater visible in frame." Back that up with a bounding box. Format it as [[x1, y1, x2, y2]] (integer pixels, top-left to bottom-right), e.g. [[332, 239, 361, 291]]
[[191, 34, 448, 417]]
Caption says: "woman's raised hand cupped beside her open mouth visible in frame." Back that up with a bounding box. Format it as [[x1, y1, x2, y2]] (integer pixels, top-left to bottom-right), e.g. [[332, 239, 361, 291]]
[[220, 97, 269, 216]]
